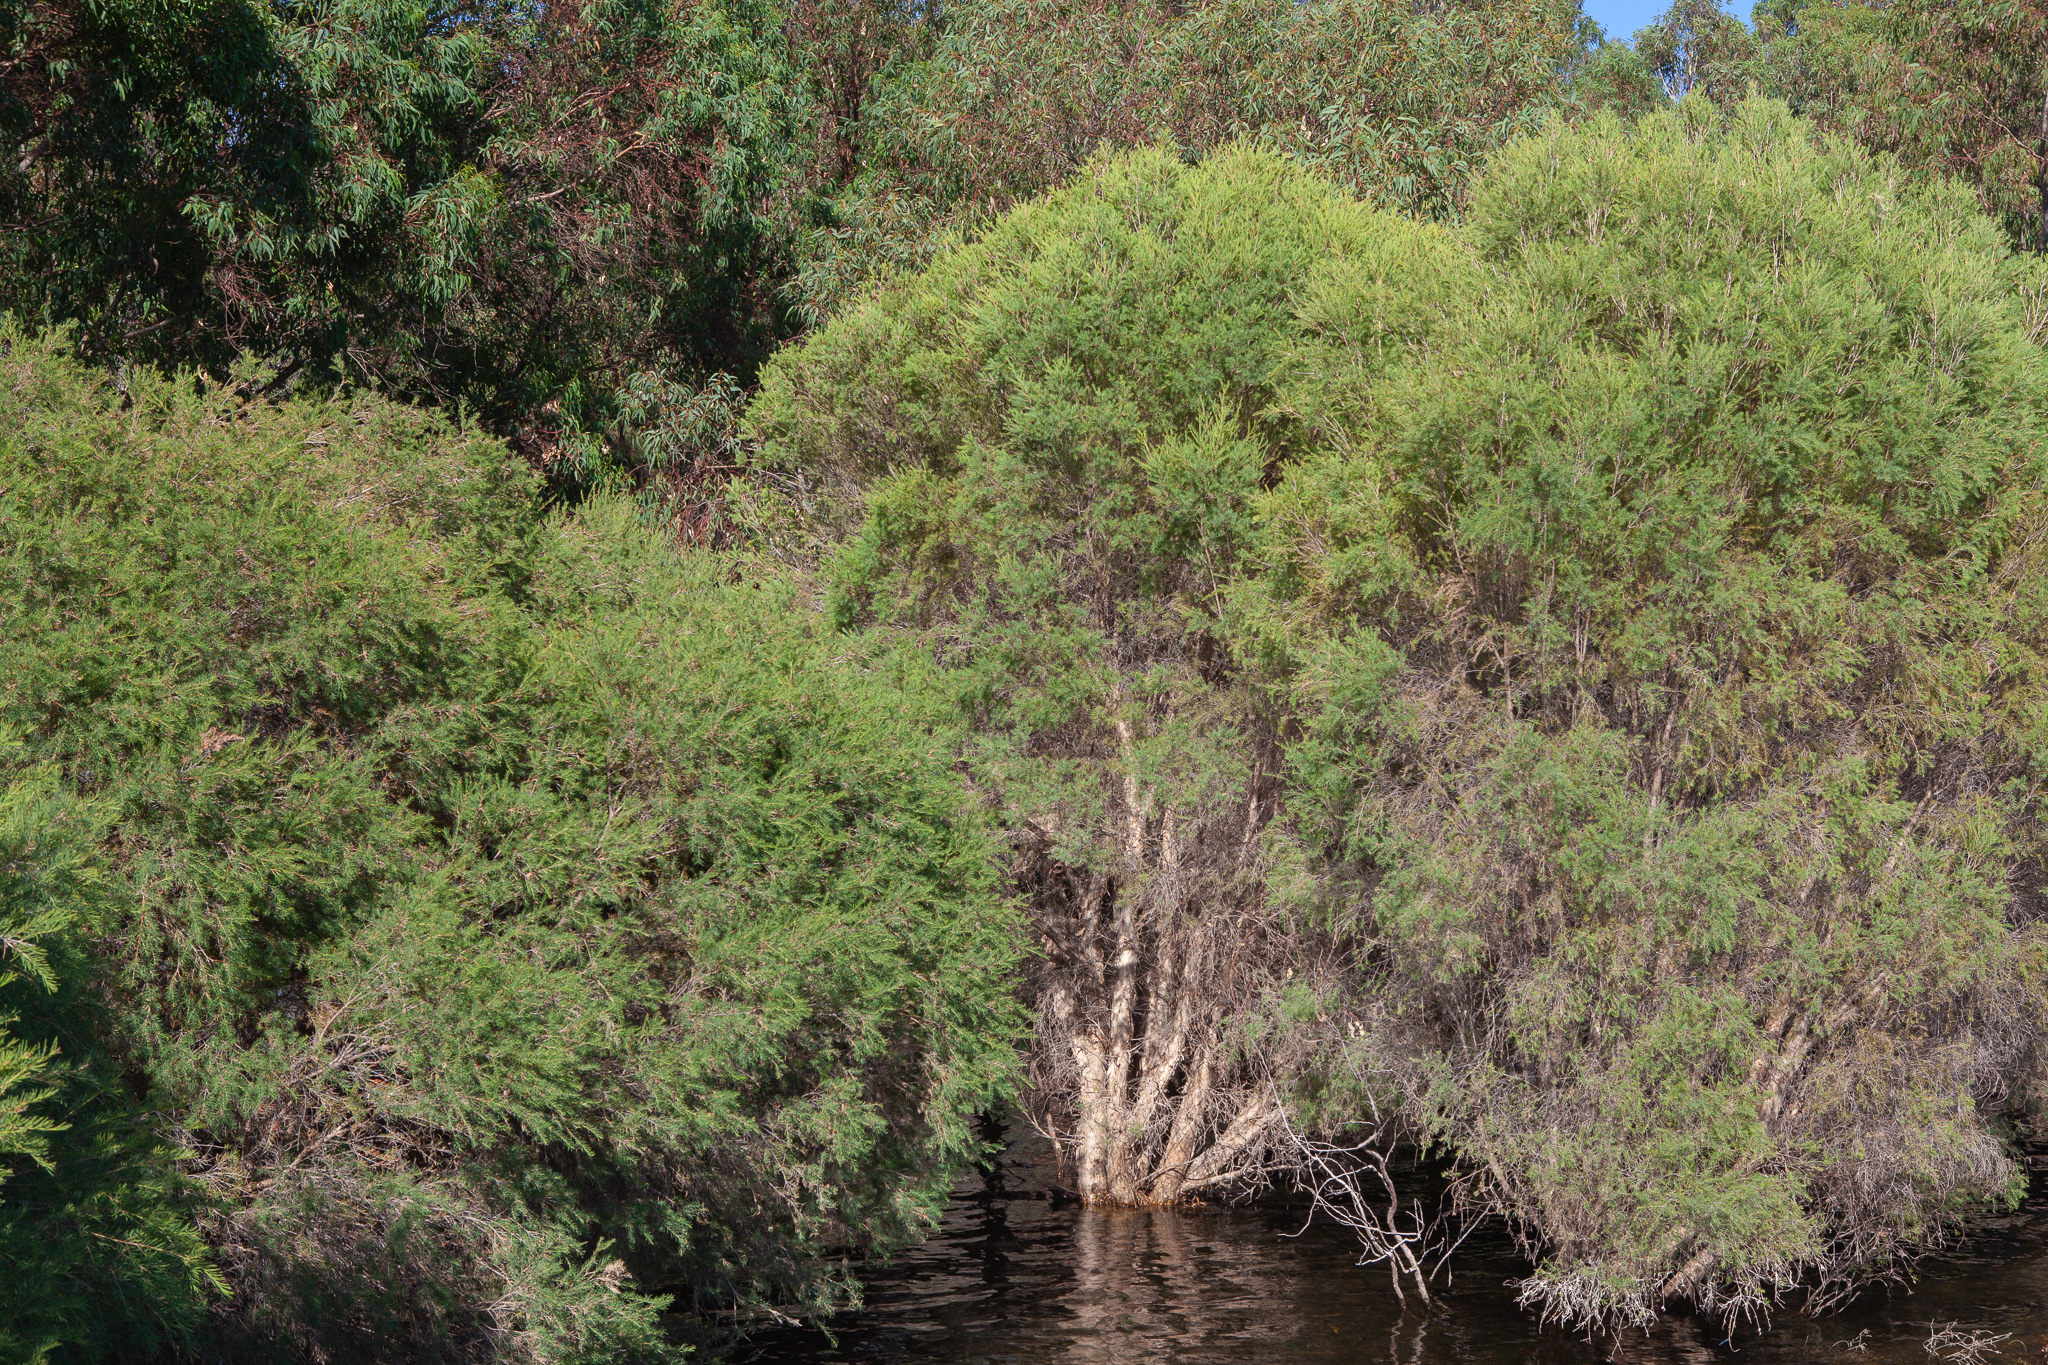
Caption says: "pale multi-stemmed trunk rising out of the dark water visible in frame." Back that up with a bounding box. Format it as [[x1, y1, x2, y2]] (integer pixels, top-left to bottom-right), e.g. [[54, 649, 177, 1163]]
[[1022, 722, 1288, 1205]]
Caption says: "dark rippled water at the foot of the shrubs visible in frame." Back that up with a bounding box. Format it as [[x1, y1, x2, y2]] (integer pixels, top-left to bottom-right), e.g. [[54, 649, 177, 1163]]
[[741, 1144, 2048, 1365]]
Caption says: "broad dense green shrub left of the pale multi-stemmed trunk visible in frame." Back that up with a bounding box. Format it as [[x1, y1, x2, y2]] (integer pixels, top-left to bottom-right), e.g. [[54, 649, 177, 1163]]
[[0, 325, 1018, 1361]]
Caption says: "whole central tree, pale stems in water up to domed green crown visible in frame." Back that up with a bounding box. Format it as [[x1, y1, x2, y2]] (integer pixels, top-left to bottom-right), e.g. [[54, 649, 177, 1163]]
[[750, 147, 1458, 1203]]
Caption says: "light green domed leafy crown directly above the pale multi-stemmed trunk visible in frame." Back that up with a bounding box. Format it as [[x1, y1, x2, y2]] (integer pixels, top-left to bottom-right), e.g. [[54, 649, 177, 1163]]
[[750, 149, 1415, 789]]
